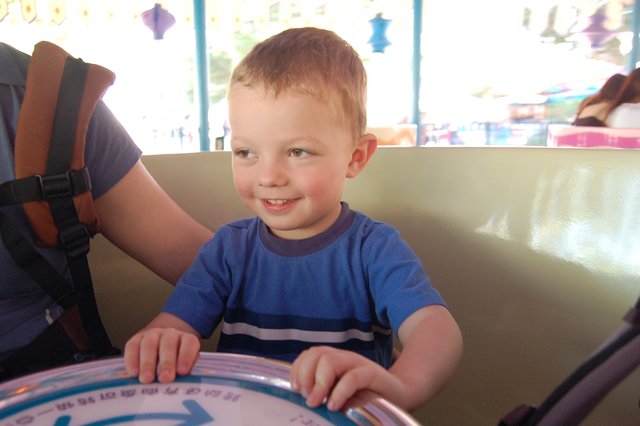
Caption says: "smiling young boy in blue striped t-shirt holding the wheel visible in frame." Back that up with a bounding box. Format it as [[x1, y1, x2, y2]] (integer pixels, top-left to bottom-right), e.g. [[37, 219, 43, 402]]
[[125, 28, 462, 410]]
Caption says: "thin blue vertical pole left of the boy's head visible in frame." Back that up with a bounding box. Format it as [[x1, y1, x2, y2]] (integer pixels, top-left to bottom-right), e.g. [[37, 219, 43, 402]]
[[193, 0, 211, 151]]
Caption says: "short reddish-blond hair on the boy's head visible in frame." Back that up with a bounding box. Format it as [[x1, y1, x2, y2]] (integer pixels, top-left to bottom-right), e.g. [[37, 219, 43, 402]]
[[229, 27, 367, 138]]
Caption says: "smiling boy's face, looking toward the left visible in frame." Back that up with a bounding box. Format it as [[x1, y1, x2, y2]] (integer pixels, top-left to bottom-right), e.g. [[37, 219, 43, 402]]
[[228, 84, 364, 239]]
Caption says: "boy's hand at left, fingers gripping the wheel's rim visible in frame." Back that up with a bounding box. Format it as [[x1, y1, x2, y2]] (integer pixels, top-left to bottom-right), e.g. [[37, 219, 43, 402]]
[[124, 312, 200, 383]]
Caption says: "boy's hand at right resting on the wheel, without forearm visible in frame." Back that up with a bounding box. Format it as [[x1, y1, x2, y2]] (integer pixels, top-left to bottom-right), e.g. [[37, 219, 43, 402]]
[[291, 346, 402, 411]]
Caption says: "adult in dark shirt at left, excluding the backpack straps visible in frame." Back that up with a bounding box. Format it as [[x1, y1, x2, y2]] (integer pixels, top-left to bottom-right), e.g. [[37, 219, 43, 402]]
[[0, 43, 212, 379]]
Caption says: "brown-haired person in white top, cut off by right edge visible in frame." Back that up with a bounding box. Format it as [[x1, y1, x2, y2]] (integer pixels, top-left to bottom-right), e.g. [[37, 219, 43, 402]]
[[606, 68, 640, 129]]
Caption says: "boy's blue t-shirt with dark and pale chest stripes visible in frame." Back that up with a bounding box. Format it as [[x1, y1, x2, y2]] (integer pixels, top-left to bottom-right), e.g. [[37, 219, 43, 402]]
[[163, 203, 444, 367]]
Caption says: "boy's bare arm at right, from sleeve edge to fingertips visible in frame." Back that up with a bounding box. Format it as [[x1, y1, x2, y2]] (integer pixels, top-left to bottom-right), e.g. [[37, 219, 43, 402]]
[[291, 306, 462, 411]]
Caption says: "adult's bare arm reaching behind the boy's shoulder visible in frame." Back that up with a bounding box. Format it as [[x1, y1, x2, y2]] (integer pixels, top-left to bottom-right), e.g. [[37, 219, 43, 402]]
[[95, 160, 213, 284]]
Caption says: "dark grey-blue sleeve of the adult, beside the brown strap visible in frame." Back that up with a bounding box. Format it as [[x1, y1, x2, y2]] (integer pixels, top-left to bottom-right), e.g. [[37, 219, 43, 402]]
[[85, 101, 142, 198]]
